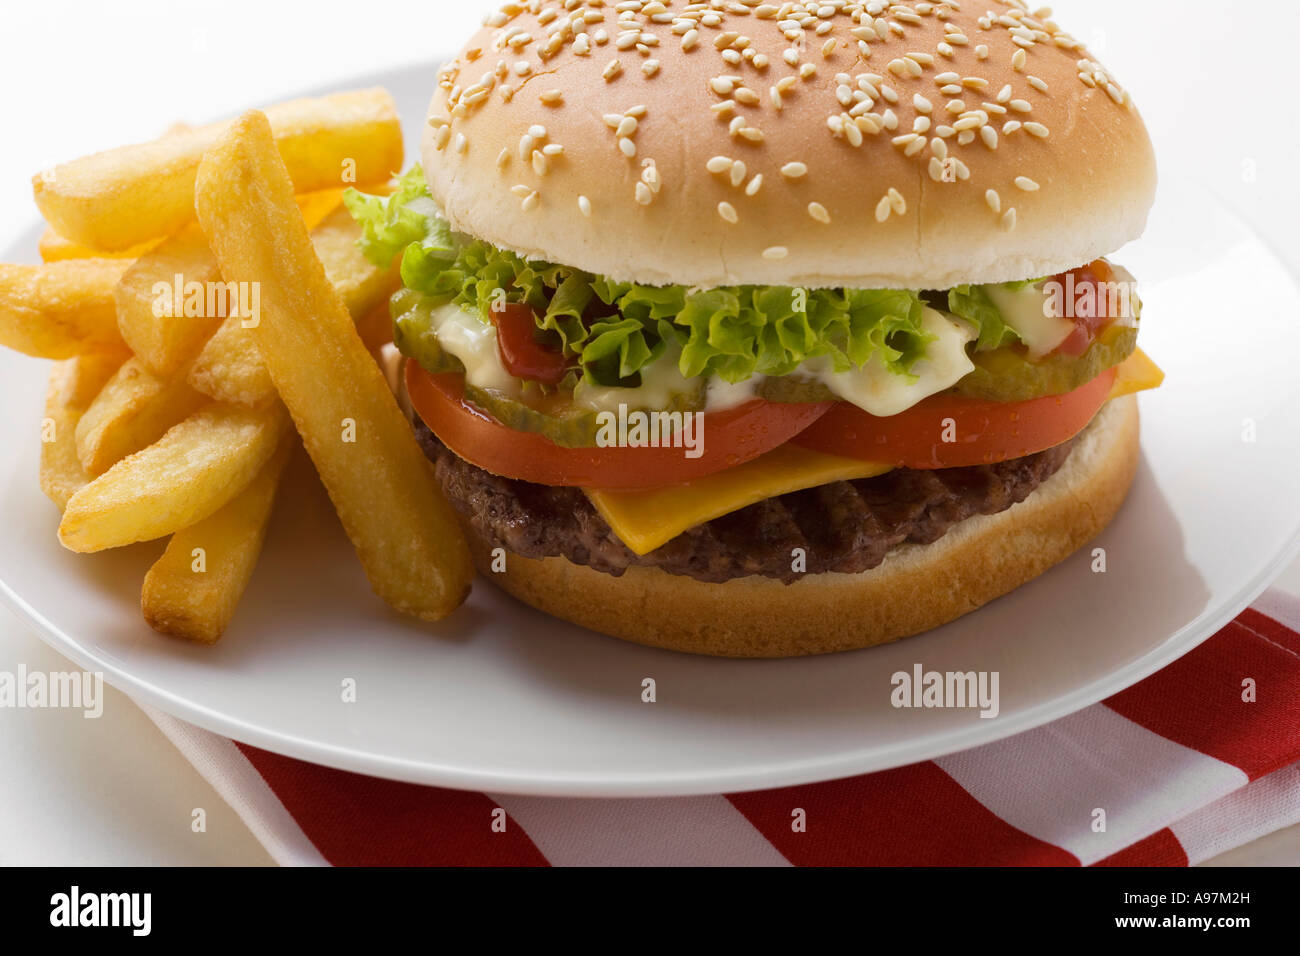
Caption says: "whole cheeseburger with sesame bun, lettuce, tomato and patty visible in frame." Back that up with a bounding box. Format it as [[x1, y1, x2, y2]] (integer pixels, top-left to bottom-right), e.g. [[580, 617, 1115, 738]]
[[347, 0, 1162, 657]]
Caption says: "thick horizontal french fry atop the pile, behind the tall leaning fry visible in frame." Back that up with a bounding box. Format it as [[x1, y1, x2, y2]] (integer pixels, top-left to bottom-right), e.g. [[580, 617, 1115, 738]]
[[33, 88, 402, 250]]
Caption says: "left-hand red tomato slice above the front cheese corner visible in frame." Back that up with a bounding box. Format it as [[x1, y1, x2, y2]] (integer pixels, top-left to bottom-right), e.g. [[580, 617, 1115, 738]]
[[406, 362, 835, 490]]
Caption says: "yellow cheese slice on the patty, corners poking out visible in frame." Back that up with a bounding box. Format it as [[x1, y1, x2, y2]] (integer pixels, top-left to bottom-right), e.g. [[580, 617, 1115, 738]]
[[586, 349, 1165, 554]]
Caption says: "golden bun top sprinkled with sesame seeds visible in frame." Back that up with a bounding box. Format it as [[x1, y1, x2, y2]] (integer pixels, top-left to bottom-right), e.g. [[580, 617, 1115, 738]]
[[423, 0, 1156, 289]]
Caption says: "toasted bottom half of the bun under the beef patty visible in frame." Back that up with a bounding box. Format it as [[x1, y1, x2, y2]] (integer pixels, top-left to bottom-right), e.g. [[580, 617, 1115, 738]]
[[467, 395, 1140, 657]]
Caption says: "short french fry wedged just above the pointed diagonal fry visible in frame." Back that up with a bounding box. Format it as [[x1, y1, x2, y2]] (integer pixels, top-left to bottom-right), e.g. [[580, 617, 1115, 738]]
[[75, 356, 208, 477]]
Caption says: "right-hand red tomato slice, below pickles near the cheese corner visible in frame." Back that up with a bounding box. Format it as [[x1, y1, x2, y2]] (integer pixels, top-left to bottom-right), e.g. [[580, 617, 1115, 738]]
[[794, 368, 1115, 468]]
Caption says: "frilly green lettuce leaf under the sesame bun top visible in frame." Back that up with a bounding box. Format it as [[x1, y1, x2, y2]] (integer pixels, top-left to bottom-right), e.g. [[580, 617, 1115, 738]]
[[345, 166, 1034, 385]]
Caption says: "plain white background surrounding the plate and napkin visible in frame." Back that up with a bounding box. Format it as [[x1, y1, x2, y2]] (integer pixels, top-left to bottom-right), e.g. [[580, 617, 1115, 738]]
[[0, 0, 1300, 864]]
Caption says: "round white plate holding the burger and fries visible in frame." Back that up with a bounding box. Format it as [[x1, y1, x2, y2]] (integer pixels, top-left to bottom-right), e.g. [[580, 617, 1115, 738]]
[[0, 68, 1300, 796]]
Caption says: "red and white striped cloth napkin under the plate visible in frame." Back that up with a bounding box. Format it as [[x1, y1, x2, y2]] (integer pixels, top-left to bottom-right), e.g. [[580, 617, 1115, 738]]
[[146, 591, 1300, 866]]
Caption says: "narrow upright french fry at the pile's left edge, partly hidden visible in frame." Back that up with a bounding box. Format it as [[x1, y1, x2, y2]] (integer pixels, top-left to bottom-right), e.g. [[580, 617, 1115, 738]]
[[40, 355, 122, 510]]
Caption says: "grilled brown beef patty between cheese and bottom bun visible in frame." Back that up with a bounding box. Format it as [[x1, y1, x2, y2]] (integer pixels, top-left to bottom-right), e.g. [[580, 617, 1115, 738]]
[[415, 418, 1074, 584]]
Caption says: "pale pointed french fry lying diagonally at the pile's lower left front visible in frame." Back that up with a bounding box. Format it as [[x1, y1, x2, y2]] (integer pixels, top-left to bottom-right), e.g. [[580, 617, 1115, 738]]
[[59, 402, 289, 553]]
